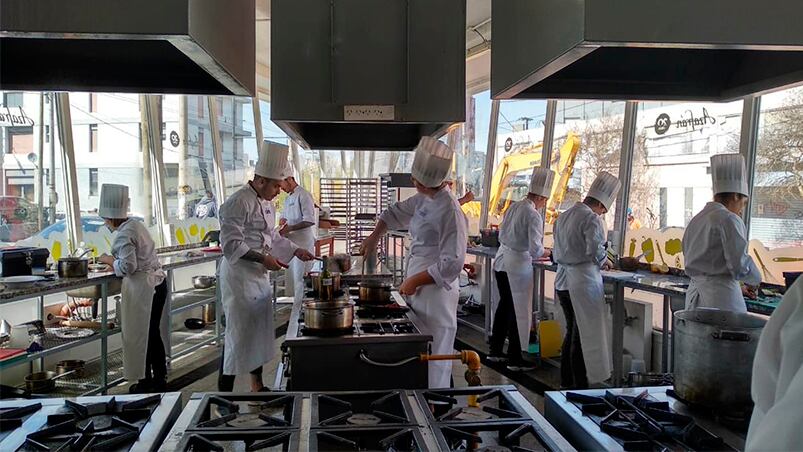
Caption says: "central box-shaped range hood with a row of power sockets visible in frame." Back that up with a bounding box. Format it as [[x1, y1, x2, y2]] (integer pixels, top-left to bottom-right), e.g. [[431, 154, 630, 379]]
[[271, 0, 466, 150]]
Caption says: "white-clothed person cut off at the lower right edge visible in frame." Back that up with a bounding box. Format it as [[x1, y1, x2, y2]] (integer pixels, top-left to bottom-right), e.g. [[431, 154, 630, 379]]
[[745, 278, 803, 451]]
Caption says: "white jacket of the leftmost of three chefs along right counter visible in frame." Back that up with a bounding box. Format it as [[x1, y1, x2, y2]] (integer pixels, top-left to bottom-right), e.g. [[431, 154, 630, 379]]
[[499, 198, 544, 259]]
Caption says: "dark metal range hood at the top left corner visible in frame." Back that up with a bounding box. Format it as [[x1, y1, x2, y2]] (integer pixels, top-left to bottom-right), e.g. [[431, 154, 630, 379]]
[[0, 0, 256, 96]]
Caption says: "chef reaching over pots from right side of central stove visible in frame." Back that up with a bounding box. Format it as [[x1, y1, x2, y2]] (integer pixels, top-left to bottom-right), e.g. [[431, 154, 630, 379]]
[[361, 137, 468, 388]]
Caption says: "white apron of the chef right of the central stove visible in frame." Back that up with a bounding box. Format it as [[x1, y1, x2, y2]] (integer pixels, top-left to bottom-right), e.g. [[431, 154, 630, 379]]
[[407, 247, 460, 389]]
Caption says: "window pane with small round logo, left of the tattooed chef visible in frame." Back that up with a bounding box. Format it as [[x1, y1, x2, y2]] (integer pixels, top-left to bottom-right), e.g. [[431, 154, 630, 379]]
[[162, 95, 218, 245]]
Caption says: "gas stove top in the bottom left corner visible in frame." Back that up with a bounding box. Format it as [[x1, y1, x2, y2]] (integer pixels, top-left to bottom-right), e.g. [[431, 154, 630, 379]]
[[0, 394, 181, 451]]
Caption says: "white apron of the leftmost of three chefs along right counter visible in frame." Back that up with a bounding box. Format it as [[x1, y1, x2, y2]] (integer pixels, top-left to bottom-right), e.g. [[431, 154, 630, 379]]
[[494, 245, 534, 351]]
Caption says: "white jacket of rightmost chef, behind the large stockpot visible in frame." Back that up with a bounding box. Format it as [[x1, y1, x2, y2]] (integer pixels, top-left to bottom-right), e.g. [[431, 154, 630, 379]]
[[683, 202, 761, 286]]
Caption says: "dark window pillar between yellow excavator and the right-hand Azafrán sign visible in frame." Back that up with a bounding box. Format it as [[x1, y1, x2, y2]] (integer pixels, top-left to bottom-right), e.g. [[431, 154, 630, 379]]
[[613, 102, 638, 256]]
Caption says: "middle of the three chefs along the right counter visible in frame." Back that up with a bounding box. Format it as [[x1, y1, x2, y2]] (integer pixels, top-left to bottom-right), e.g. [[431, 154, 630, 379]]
[[552, 171, 620, 389]]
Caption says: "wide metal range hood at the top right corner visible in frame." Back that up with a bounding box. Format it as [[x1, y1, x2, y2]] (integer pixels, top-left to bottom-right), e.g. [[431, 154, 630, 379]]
[[491, 0, 803, 101]]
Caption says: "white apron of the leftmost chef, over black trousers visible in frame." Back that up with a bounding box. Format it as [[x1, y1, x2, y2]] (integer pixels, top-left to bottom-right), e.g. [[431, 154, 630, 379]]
[[120, 270, 168, 381]]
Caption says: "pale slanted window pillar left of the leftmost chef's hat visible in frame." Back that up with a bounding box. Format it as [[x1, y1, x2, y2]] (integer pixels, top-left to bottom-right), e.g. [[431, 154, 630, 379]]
[[56, 93, 83, 247]]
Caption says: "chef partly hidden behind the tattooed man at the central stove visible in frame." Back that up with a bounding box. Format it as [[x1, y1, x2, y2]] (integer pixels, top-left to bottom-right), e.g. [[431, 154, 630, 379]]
[[279, 168, 317, 301]]
